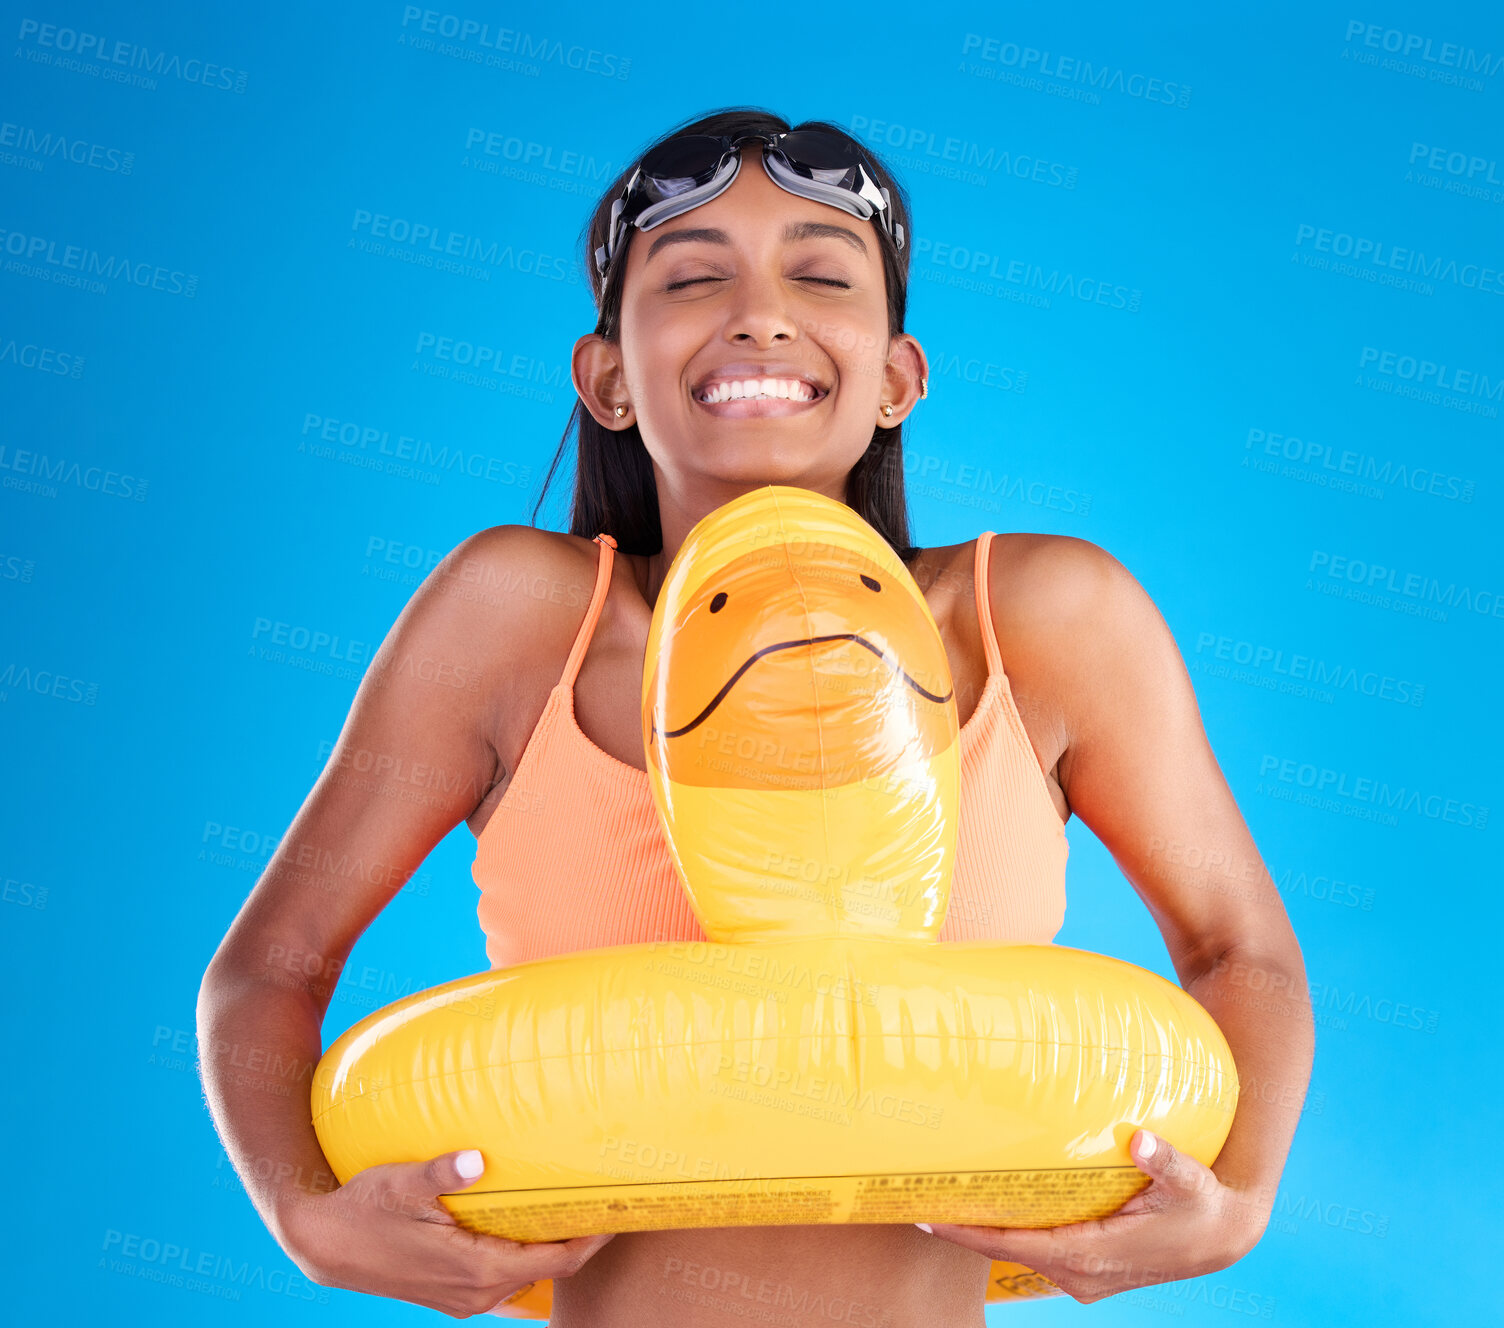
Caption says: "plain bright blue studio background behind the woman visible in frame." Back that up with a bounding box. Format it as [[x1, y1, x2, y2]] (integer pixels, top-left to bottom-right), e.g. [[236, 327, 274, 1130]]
[[0, 3, 1504, 1325]]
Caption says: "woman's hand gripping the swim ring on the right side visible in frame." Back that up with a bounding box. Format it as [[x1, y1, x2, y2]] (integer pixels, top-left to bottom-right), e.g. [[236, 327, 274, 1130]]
[[929, 1129, 1269, 1305]]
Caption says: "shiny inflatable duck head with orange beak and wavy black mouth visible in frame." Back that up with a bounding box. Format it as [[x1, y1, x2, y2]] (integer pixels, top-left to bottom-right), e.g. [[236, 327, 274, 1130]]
[[642, 484, 960, 943]]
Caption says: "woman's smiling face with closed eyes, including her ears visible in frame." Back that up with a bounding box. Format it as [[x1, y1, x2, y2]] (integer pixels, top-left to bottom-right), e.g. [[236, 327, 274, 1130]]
[[576, 144, 928, 514]]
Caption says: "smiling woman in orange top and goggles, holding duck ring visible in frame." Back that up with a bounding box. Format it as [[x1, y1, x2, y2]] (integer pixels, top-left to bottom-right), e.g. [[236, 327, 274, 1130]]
[[200, 108, 1313, 1328]]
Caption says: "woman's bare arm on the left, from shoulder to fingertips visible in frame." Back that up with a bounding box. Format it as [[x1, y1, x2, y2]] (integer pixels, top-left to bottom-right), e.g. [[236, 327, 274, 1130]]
[[199, 526, 611, 1317]]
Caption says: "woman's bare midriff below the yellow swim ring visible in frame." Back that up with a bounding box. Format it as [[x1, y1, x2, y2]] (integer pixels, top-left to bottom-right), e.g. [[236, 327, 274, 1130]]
[[549, 1223, 991, 1328]]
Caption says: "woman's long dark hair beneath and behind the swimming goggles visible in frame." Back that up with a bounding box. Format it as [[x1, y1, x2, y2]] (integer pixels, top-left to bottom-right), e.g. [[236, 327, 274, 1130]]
[[532, 107, 916, 562]]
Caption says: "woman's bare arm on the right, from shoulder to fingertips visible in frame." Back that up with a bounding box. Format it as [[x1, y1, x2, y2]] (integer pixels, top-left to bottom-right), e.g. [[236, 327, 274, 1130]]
[[932, 537, 1314, 1302]]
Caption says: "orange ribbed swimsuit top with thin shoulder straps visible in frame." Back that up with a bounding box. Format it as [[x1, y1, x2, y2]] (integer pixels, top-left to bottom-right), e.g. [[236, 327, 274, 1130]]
[[471, 531, 1069, 969]]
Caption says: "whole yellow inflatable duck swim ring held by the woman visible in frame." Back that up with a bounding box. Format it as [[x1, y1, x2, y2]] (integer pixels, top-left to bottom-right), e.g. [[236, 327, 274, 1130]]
[[311, 486, 1238, 1317]]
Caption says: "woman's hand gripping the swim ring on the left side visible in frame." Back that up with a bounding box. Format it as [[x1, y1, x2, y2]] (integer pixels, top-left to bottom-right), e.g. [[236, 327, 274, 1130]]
[[284, 1149, 615, 1319]]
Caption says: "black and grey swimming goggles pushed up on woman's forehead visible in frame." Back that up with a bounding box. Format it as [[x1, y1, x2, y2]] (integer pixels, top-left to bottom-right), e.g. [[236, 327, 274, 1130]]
[[596, 129, 904, 280]]
